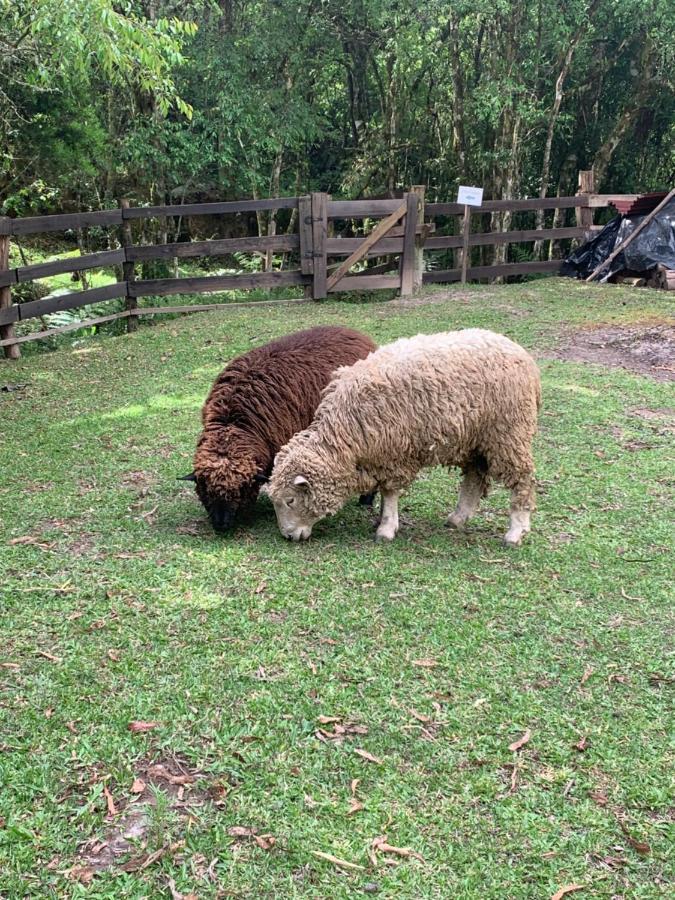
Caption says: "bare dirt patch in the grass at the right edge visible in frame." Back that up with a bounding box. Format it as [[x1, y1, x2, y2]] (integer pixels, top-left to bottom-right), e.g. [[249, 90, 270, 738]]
[[553, 322, 675, 381]]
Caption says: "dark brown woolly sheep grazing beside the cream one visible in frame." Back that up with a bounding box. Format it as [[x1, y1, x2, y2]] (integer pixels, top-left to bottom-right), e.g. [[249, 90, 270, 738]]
[[181, 325, 376, 531]]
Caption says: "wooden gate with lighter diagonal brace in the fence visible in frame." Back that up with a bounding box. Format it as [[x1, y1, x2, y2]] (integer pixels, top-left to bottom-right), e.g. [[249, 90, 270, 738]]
[[298, 186, 430, 300]]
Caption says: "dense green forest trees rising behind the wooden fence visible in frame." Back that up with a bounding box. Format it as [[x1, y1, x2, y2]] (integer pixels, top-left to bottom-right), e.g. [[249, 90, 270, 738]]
[[0, 0, 675, 214]]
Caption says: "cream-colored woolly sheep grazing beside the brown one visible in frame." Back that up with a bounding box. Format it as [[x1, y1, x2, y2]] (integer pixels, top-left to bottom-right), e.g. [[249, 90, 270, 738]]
[[267, 329, 541, 545]]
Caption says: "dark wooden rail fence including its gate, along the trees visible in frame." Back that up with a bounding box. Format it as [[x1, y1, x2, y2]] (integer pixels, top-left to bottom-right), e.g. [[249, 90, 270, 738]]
[[0, 173, 628, 358]]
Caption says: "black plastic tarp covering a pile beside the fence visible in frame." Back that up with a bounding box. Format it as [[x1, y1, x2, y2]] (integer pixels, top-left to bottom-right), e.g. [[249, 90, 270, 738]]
[[560, 197, 675, 281]]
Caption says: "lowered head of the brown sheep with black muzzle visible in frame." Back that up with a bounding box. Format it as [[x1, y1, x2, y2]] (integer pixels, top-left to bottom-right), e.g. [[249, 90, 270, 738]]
[[182, 455, 267, 532]]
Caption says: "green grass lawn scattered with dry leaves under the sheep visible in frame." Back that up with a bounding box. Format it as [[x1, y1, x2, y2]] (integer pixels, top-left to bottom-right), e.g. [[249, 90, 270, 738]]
[[0, 279, 675, 900]]
